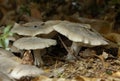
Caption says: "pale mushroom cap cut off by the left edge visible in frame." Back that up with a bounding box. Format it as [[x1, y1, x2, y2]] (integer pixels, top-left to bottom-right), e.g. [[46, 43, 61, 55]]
[[0, 48, 21, 74]]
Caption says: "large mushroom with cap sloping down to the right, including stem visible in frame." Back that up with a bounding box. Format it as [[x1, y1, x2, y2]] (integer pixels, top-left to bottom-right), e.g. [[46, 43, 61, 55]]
[[53, 21, 108, 60]]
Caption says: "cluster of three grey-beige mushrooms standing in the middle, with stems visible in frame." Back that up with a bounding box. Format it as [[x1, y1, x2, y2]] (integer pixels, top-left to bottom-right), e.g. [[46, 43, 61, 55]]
[[11, 20, 108, 66]]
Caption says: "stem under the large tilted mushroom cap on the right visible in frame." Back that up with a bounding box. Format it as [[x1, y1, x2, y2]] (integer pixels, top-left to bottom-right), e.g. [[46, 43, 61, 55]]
[[66, 42, 81, 61]]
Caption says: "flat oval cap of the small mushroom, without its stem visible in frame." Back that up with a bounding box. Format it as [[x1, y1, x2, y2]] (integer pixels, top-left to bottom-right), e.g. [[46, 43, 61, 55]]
[[13, 37, 56, 50]]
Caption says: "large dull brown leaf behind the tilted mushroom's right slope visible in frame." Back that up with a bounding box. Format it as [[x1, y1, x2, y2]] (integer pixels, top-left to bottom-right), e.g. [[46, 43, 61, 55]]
[[69, 16, 112, 34]]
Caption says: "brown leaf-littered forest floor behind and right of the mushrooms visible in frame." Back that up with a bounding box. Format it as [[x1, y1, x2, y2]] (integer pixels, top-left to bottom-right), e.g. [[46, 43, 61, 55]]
[[0, 0, 120, 81]]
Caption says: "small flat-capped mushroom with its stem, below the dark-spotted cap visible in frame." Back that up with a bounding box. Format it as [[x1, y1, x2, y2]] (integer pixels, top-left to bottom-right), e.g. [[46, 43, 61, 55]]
[[13, 37, 56, 66]]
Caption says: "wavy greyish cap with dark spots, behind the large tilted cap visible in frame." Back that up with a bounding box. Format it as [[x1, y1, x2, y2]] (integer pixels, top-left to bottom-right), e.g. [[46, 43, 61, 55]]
[[11, 20, 60, 36]]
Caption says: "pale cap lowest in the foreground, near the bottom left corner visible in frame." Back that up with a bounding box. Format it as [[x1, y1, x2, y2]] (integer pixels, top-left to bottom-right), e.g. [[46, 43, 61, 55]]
[[10, 64, 44, 79]]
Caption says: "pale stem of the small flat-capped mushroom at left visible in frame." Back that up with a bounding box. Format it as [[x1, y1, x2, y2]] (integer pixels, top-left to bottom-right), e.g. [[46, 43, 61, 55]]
[[33, 49, 46, 66]]
